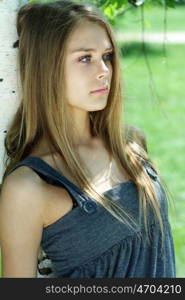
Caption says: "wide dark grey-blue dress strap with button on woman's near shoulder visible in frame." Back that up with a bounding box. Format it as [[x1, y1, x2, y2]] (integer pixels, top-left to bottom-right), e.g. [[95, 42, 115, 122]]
[[7, 156, 97, 214]]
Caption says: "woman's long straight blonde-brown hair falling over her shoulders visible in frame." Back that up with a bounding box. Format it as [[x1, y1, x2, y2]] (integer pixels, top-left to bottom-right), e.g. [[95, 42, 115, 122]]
[[3, 1, 166, 246]]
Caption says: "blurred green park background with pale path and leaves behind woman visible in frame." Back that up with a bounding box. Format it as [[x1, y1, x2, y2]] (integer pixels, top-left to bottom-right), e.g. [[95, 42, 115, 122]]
[[0, 0, 185, 278]]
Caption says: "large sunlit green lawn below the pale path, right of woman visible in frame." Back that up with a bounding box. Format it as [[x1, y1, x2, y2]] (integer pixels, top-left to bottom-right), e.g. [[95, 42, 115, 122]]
[[121, 43, 185, 278]]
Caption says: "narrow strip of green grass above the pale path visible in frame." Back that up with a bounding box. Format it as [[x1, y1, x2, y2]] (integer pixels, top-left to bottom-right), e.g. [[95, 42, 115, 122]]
[[116, 6, 185, 32]]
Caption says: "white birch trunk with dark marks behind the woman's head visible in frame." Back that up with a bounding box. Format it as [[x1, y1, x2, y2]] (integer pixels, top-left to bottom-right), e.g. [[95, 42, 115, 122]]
[[0, 0, 28, 182]]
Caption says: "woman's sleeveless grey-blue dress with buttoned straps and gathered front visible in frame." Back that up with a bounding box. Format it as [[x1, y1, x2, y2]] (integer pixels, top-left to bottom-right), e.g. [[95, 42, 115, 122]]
[[11, 156, 176, 278]]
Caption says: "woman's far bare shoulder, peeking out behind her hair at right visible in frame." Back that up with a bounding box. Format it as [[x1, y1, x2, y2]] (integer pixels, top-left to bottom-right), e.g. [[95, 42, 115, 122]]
[[125, 125, 148, 152]]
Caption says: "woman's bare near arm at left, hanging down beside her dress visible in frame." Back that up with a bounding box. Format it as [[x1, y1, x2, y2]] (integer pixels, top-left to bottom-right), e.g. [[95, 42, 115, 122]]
[[0, 171, 44, 278]]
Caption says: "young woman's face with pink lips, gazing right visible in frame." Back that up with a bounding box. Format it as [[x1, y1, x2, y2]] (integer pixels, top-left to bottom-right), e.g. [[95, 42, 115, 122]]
[[64, 20, 113, 111]]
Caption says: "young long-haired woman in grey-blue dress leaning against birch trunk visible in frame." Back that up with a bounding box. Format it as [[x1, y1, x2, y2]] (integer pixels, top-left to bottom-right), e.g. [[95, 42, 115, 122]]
[[0, 1, 176, 278]]
